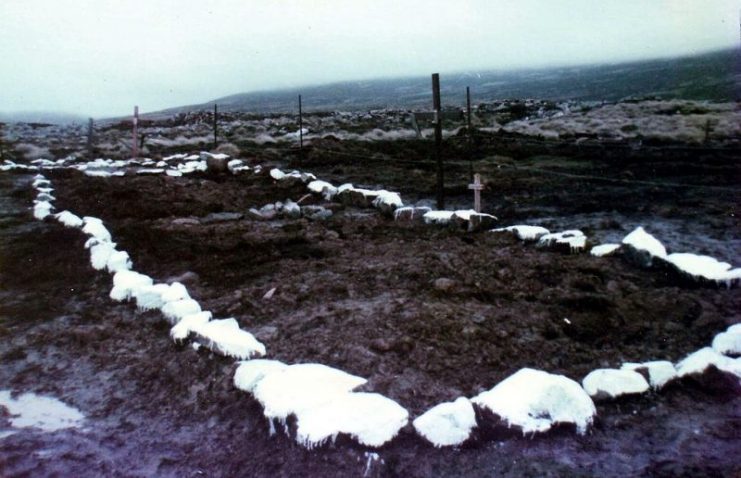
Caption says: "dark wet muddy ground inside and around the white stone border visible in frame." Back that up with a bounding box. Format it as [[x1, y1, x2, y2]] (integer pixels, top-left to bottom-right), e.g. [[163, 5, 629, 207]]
[[0, 136, 741, 476]]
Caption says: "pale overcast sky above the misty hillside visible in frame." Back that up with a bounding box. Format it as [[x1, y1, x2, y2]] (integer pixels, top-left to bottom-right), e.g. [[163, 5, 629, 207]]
[[0, 0, 741, 116]]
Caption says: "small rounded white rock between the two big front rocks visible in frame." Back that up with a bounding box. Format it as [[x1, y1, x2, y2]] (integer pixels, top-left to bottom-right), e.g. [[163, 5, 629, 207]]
[[412, 397, 476, 447]]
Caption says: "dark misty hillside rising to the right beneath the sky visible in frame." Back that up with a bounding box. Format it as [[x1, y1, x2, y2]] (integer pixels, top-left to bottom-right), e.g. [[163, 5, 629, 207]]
[[159, 49, 741, 113]]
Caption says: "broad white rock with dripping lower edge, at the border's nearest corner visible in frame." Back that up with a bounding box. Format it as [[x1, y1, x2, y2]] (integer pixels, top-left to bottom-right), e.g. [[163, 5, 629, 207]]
[[296, 393, 409, 448]]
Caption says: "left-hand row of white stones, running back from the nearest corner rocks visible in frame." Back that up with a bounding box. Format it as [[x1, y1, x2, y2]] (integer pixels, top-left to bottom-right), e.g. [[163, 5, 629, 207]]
[[28, 171, 409, 448]]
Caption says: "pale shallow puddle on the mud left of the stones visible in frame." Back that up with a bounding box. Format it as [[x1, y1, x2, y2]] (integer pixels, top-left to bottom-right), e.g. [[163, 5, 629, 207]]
[[0, 390, 85, 438]]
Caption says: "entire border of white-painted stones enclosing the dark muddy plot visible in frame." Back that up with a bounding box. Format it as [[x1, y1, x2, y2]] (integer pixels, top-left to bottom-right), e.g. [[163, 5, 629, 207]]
[[14, 159, 741, 448]]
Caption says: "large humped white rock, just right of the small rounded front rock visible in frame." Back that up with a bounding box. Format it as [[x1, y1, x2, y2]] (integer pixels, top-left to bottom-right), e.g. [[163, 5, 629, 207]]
[[471, 368, 597, 434]]
